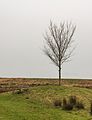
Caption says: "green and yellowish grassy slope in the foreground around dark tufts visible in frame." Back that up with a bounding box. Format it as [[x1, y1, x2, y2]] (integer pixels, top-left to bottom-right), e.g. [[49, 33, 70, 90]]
[[0, 86, 92, 120]]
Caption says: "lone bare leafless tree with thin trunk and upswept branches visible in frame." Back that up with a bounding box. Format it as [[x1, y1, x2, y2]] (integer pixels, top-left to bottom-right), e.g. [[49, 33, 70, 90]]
[[43, 21, 76, 85]]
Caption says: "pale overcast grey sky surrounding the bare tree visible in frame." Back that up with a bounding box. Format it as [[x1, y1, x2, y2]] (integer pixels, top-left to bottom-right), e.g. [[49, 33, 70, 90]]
[[0, 0, 92, 78]]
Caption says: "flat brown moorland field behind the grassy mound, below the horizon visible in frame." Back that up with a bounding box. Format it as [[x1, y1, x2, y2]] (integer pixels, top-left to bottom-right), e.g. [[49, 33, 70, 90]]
[[0, 78, 92, 92]]
